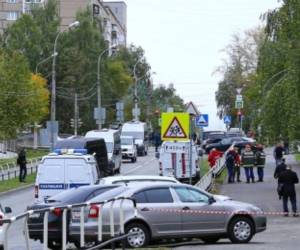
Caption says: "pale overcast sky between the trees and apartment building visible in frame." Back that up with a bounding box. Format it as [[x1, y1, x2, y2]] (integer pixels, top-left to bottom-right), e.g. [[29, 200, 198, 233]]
[[110, 0, 280, 129]]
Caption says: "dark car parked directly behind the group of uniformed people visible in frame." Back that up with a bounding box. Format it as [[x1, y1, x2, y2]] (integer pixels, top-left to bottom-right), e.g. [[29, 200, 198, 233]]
[[205, 137, 255, 154]]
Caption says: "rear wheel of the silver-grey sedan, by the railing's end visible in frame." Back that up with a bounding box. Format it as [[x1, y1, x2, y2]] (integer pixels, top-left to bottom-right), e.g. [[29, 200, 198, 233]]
[[126, 223, 150, 248]]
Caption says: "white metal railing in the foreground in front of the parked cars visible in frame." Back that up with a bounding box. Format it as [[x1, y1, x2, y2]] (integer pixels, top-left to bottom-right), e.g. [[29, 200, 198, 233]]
[[0, 197, 137, 250]]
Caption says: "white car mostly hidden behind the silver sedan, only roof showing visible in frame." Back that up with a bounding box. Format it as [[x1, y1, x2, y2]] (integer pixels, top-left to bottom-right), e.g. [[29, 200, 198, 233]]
[[99, 175, 180, 185]]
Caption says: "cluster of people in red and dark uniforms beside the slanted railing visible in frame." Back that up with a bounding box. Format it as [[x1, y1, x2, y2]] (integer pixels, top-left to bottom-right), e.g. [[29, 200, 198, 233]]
[[208, 144, 266, 183]]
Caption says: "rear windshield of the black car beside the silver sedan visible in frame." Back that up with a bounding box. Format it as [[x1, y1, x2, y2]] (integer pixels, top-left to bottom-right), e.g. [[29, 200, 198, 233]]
[[46, 186, 117, 204]]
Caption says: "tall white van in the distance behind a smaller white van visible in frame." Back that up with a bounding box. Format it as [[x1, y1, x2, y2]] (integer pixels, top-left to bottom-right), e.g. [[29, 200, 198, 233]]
[[121, 121, 149, 155]]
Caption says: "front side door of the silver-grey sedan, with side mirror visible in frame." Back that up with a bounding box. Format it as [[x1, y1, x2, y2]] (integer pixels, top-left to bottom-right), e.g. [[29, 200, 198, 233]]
[[174, 187, 225, 235]]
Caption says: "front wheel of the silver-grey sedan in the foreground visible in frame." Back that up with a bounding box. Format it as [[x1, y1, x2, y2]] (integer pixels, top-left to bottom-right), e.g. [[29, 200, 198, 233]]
[[228, 217, 254, 243]]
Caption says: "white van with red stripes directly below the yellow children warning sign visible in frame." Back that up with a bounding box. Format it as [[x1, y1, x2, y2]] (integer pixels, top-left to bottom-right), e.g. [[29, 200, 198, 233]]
[[159, 141, 200, 183]]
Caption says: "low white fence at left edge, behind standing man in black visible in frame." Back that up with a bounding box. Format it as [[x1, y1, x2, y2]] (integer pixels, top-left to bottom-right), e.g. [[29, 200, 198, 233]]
[[0, 158, 41, 182]]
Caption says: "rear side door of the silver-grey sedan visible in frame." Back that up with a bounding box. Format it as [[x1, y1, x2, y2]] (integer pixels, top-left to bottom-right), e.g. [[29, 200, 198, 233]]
[[132, 187, 181, 236]]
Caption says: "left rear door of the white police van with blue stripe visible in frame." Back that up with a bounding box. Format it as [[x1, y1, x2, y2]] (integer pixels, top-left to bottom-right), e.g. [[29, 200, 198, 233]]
[[38, 158, 66, 201]]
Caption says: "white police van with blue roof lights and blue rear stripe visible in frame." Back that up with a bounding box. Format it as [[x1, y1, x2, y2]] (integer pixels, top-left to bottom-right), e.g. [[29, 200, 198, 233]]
[[35, 150, 100, 202]]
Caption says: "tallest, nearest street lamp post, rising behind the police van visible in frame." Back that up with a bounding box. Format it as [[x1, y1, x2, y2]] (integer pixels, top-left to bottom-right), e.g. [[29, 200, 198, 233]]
[[50, 21, 80, 150]]
